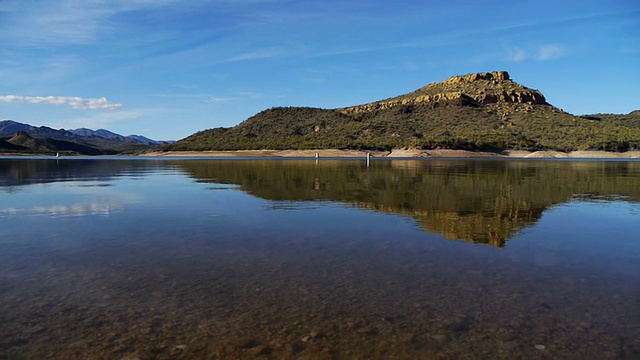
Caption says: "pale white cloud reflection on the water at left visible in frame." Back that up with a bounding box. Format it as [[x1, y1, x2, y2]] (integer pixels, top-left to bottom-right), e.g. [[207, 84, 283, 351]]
[[0, 203, 122, 217]]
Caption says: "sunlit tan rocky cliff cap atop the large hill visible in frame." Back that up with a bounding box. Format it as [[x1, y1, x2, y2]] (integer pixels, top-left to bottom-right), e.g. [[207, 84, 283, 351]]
[[338, 71, 549, 114]]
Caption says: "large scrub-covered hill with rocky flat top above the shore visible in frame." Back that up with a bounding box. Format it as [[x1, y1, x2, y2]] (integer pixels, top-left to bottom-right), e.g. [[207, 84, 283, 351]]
[[162, 71, 640, 151]]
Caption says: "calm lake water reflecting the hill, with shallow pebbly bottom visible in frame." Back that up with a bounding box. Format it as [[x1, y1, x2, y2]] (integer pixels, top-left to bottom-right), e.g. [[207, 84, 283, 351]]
[[0, 158, 640, 359]]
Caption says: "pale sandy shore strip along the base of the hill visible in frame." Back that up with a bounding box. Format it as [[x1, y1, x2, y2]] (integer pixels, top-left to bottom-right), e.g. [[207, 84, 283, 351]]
[[141, 149, 640, 159]]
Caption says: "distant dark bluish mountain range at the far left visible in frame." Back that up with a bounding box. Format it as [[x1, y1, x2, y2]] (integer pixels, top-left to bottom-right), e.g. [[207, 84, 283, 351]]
[[0, 120, 171, 155]]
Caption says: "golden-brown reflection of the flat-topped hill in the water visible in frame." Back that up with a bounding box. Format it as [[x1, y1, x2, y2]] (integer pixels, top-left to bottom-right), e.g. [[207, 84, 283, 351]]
[[179, 160, 640, 246]]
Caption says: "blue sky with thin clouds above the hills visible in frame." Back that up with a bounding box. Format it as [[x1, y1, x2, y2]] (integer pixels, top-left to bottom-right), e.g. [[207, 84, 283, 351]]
[[0, 0, 640, 140]]
